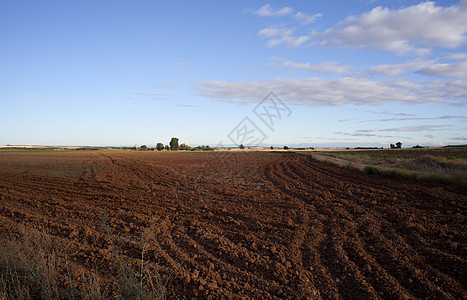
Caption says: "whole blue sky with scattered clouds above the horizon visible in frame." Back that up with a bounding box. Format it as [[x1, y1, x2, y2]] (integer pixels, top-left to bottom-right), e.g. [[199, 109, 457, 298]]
[[0, 0, 467, 147]]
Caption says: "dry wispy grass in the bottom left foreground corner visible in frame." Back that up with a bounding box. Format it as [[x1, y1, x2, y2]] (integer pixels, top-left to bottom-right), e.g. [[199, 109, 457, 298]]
[[0, 220, 167, 300]]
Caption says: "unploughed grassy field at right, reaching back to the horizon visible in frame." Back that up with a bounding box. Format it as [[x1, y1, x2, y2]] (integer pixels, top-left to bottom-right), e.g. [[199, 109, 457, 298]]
[[312, 147, 467, 185]]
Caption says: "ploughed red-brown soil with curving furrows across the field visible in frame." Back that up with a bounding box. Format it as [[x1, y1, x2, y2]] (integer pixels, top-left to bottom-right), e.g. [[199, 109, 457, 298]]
[[0, 151, 467, 299]]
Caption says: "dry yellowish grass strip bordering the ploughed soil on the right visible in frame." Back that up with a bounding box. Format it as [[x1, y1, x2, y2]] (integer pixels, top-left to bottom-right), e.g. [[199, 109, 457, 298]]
[[312, 151, 467, 186]]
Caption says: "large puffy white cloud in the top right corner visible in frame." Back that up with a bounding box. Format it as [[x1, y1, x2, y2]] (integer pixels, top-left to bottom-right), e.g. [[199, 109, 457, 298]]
[[313, 0, 467, 54]]
